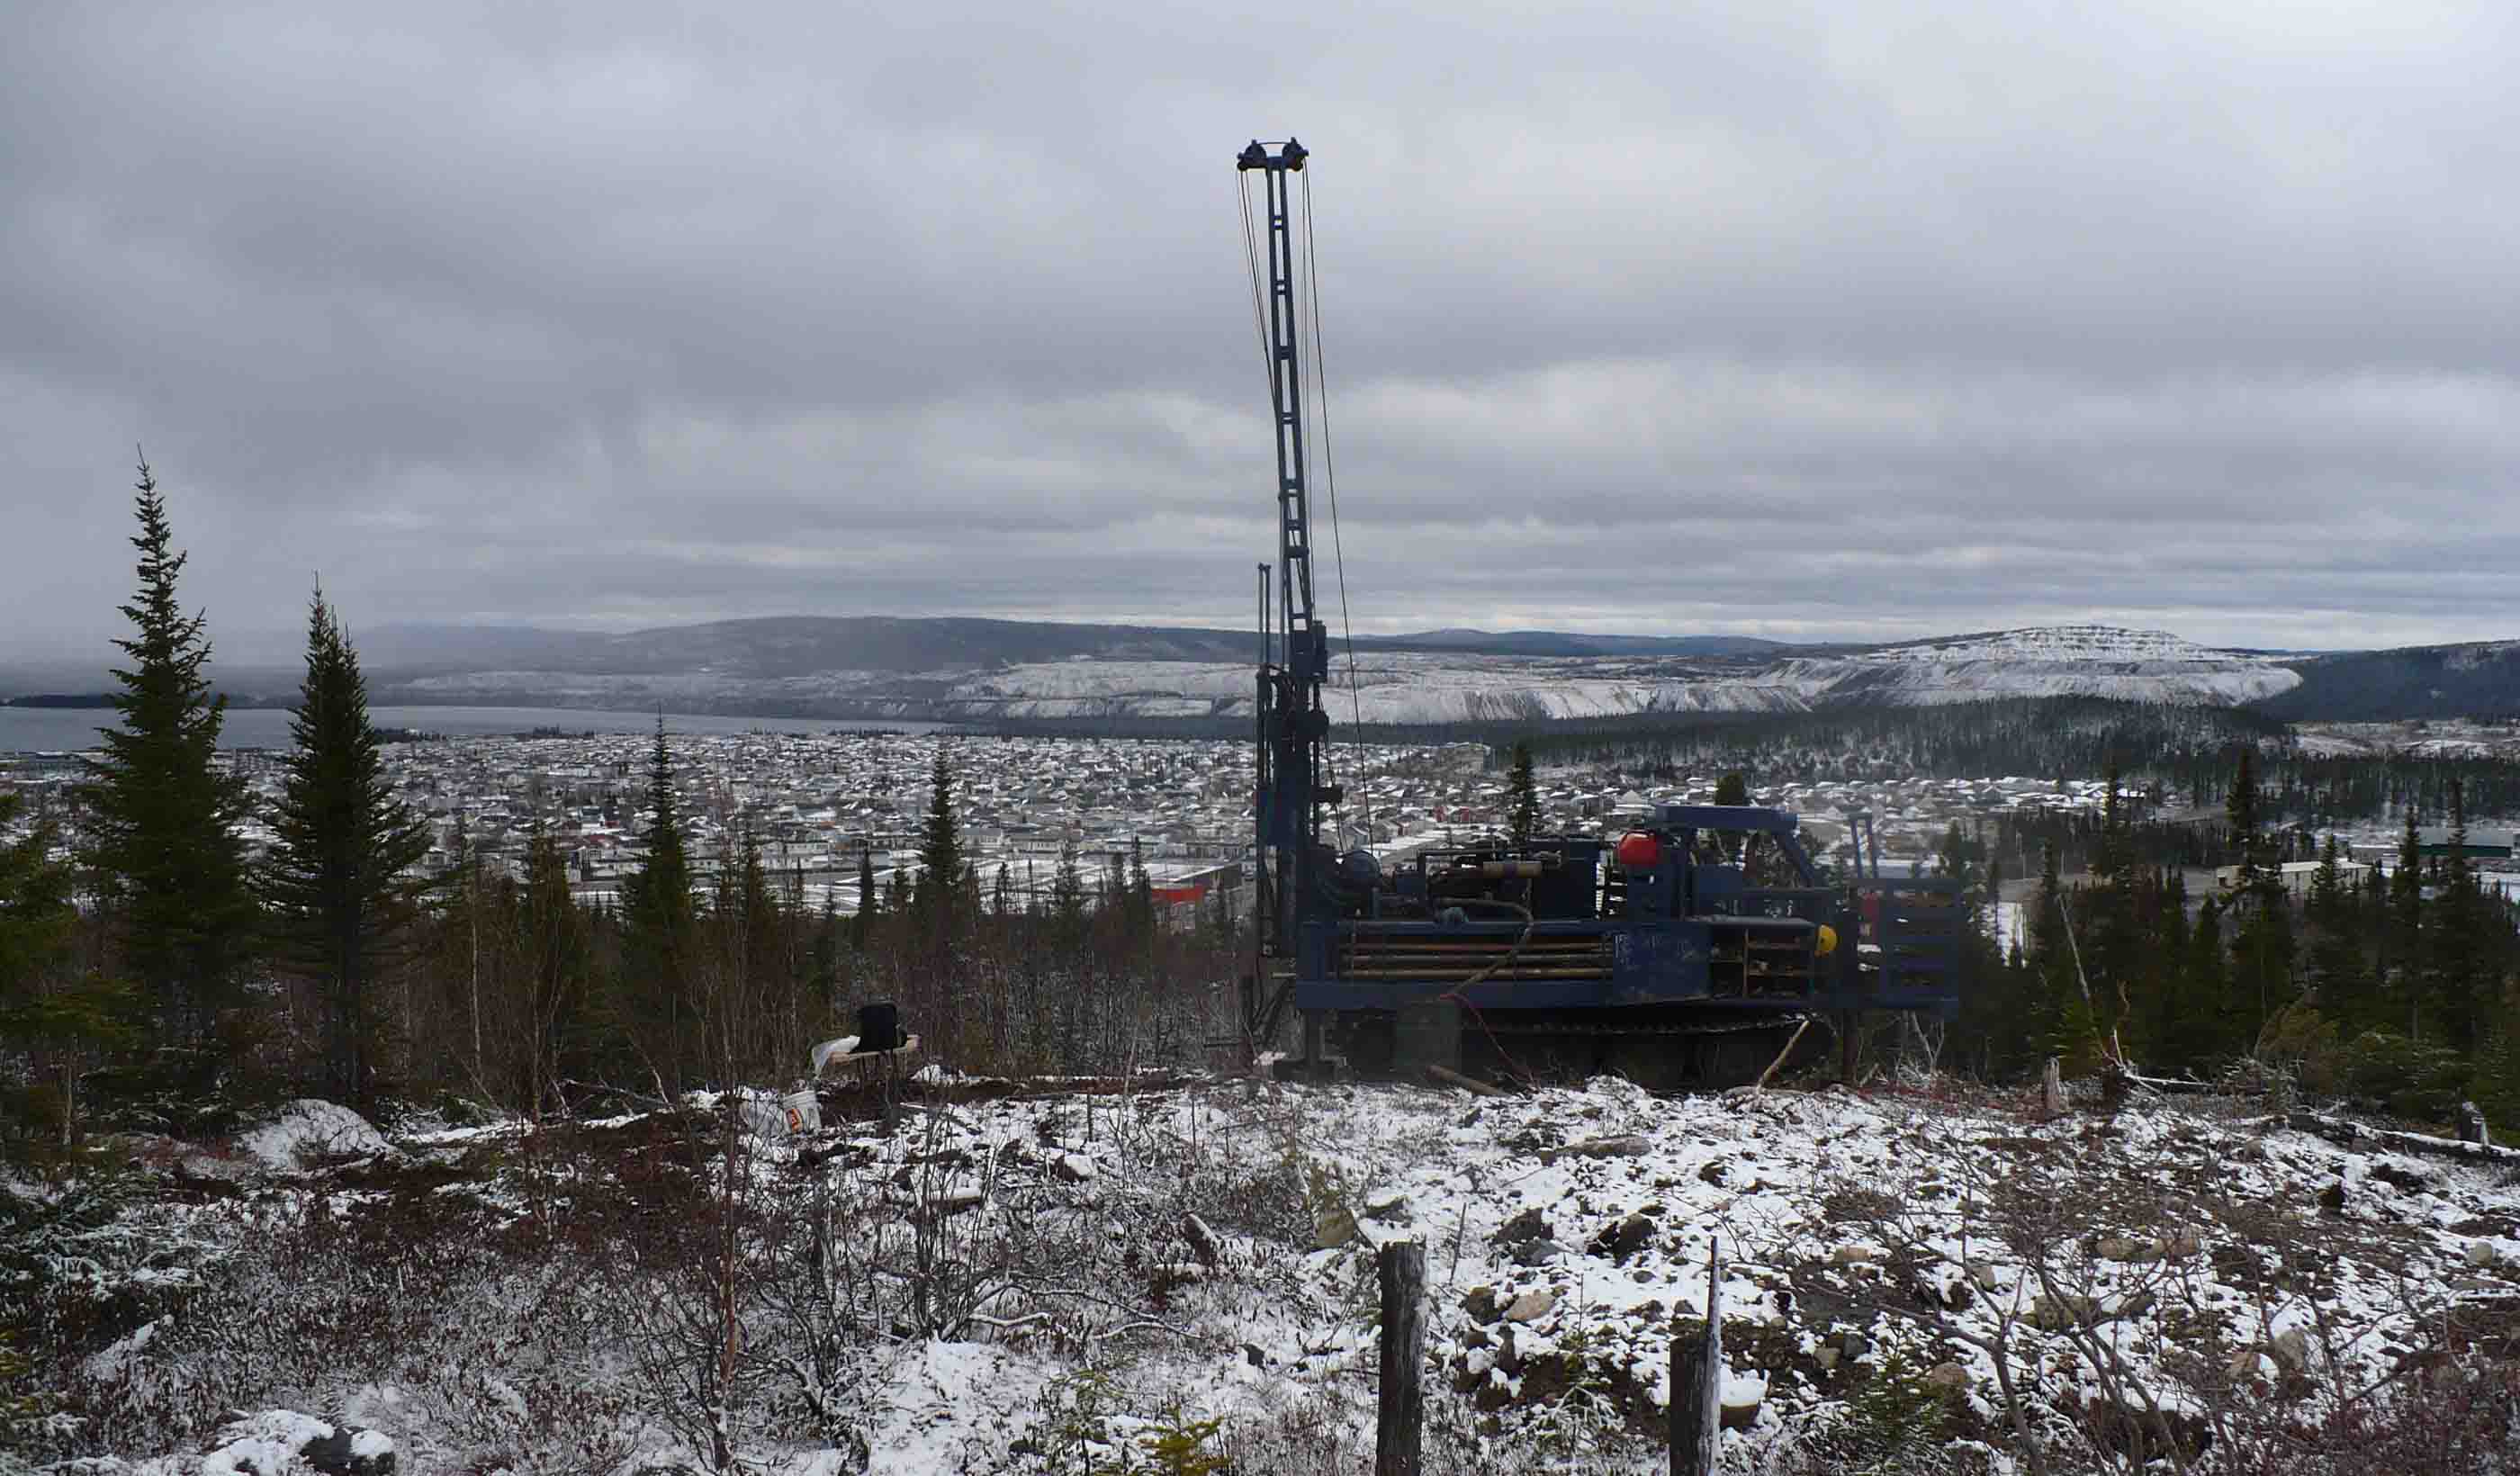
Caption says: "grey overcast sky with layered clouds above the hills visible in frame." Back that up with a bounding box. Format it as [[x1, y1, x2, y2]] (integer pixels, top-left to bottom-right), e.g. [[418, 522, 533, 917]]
[[0, 0, 2520, 657]]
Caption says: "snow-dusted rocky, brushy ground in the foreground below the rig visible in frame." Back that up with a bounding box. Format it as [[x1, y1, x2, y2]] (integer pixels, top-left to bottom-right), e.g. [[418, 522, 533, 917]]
[[34, 1078, 2520, 1476]]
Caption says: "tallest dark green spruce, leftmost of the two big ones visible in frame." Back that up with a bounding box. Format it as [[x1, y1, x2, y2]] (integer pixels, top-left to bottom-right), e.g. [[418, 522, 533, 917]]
[[78, 458, 259, 1045]]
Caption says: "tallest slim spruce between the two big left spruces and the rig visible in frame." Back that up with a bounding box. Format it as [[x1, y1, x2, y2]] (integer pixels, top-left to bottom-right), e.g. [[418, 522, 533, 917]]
[[615, 716, 706, 1085]]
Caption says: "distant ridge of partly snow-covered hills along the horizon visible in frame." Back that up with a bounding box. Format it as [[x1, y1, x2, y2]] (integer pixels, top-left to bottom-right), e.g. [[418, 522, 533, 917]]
[[18, 617, 2520, 725]]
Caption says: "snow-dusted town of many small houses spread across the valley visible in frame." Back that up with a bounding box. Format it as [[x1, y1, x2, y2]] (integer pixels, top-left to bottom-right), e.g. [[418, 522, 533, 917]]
[[0, 731, 2167, 914]]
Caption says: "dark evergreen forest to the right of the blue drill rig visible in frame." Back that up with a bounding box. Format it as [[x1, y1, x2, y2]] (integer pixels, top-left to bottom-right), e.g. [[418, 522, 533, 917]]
[[1938, 751, 2520, 1129]]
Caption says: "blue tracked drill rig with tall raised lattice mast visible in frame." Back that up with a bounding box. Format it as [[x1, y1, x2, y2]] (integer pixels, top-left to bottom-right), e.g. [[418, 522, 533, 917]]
[[1235, 139, 1968, 1088]]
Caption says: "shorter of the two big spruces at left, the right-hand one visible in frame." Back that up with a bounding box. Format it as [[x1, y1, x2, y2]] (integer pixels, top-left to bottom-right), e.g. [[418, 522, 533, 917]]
[[259, 587, 428, 1111]]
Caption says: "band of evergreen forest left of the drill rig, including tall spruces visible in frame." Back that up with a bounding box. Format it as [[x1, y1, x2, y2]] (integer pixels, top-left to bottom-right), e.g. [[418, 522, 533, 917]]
[[0, 464, 1240, 1146]]
